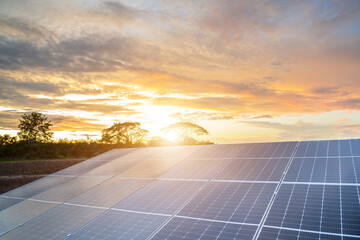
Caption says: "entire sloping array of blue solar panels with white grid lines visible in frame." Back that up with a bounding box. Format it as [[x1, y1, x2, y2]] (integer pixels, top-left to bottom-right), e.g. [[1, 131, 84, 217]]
[[0, 139, 360, 240]]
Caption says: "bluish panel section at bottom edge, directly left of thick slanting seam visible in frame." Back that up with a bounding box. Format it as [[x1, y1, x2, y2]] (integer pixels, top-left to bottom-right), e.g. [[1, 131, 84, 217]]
[[151, 217, 257, 240]]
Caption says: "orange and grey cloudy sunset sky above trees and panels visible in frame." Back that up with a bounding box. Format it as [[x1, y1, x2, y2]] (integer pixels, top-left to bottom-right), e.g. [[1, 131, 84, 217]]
[[0, 0, 360, 143]]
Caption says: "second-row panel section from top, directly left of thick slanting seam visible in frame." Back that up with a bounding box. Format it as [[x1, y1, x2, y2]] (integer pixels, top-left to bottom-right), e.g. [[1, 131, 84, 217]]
[[216, 158, 289, 181]]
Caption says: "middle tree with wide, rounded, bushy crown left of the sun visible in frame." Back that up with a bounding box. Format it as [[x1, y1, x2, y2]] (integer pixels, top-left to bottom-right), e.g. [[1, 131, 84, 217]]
[[101, 122, 149, 144]]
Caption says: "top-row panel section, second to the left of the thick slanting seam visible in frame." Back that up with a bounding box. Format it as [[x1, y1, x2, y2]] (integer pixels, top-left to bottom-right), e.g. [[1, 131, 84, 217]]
[[189, 144, 245, 159]]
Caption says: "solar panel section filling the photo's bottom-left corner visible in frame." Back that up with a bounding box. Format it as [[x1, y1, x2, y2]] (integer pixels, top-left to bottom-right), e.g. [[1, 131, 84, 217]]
[[3, 205, 104, 240]]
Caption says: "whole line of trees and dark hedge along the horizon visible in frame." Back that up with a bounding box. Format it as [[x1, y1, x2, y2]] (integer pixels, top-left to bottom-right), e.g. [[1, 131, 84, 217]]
[[0, 112, 213, 160]]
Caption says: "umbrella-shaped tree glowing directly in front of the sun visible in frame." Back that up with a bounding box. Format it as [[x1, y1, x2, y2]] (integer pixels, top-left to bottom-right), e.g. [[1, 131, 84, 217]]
[[161, 122, 209, 144]]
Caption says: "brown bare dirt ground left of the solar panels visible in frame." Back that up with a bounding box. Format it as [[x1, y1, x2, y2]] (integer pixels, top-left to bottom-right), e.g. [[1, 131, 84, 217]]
[[0, 159, 84, 194]]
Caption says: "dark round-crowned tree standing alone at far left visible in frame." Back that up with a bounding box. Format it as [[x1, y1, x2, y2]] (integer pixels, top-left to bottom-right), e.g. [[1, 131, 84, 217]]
[[18, 112, 54, 142]]
